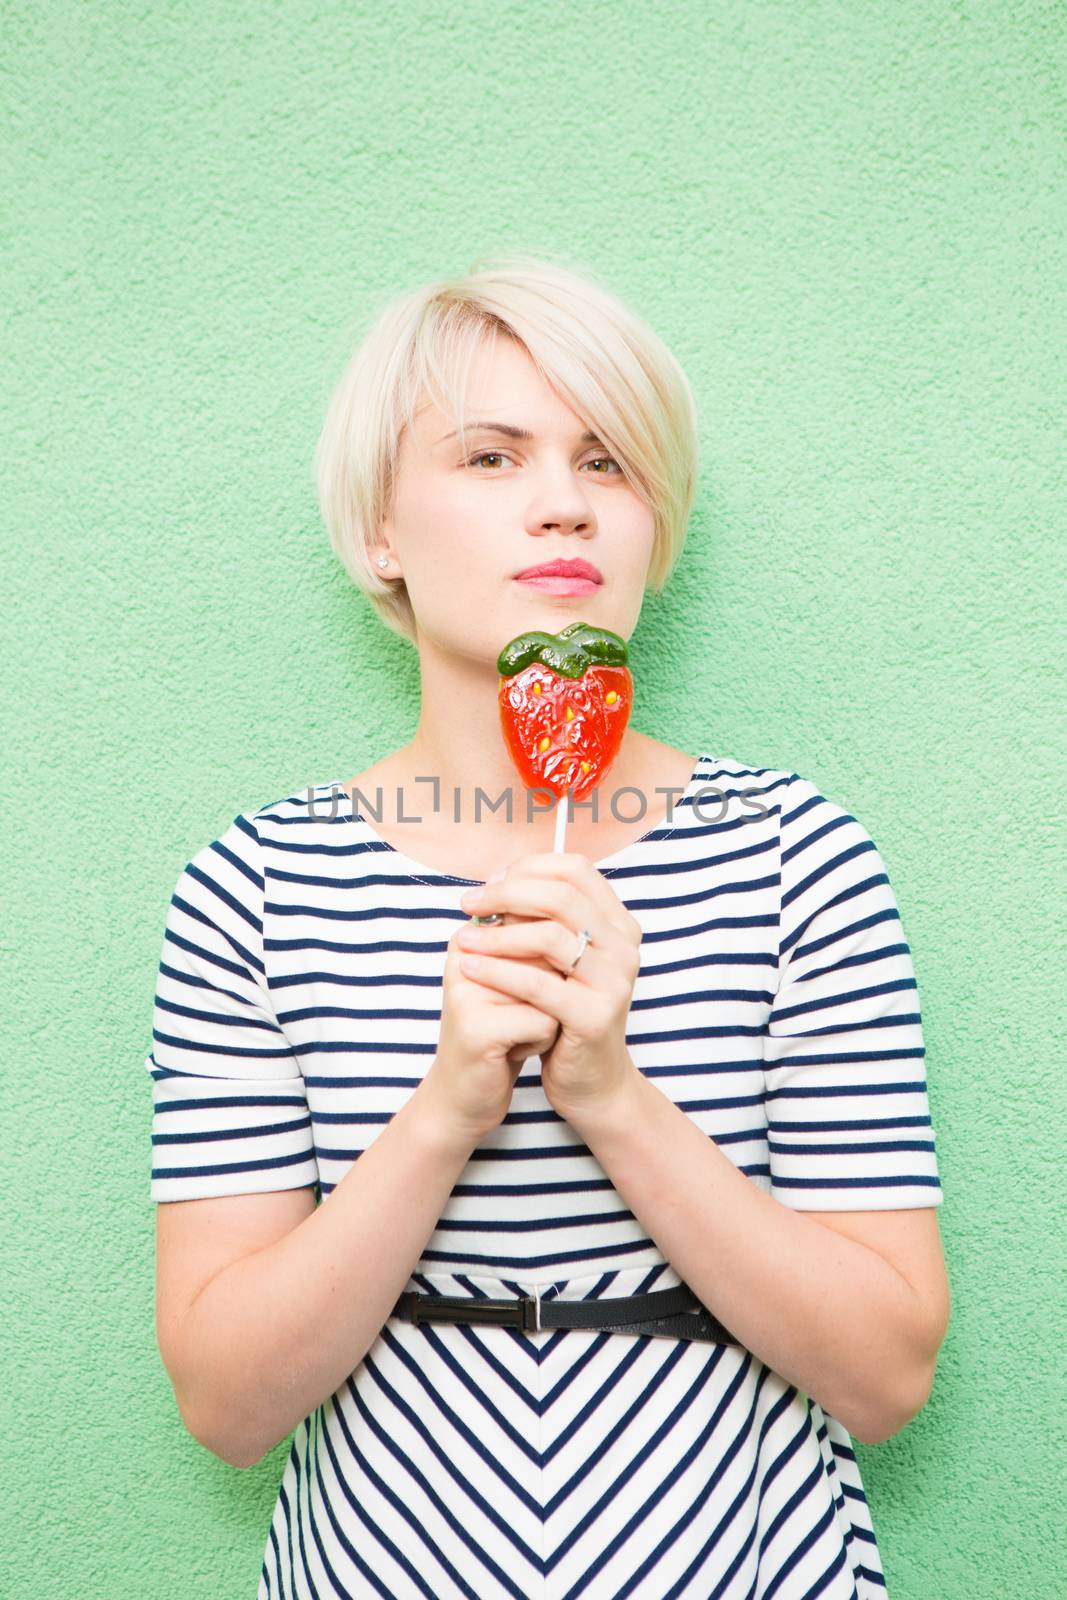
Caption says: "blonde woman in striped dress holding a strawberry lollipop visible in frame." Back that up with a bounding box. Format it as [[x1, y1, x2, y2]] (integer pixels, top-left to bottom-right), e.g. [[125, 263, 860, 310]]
[[146, 259, 949, 1600]]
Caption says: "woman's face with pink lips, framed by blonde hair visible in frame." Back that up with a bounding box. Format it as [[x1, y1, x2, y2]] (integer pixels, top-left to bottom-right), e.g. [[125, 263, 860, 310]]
[[382, 334, 654, 662]]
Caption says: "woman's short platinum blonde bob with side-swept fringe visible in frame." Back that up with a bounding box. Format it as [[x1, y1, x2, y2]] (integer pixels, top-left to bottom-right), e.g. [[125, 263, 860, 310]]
[[314, 254, 697, 643]]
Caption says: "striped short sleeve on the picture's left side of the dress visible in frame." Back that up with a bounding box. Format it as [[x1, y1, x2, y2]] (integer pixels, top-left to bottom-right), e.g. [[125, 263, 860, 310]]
[[144, 813, 318, 1200]]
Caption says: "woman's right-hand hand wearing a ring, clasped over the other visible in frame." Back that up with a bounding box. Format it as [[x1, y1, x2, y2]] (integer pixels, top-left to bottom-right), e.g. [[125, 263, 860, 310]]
[[456, 851, 641, 1120]]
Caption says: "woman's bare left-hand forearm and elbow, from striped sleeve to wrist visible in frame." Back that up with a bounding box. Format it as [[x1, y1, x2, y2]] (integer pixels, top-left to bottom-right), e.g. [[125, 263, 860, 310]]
[[157, 1078, 474, 1467]]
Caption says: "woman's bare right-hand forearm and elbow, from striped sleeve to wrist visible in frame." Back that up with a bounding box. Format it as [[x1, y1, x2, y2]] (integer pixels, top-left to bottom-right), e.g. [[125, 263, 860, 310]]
[[569, 1066, 950, 1445]]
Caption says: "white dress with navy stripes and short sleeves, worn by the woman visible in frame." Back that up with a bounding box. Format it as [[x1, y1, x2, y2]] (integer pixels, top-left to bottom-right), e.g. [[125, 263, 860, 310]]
[[144, 755, 942, 1600]]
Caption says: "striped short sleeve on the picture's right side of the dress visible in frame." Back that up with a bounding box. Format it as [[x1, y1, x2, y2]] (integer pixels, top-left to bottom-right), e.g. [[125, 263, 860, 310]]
[[763, 773, 944, 1211]]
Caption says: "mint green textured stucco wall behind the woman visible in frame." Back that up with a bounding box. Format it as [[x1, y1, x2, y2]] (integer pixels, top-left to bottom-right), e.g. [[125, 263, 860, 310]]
[[0, 0, 1067, 1600]]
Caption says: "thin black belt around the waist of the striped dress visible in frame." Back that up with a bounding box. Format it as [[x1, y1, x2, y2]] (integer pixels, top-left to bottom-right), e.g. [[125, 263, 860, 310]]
[[392, 1283, 737, 1344]]
